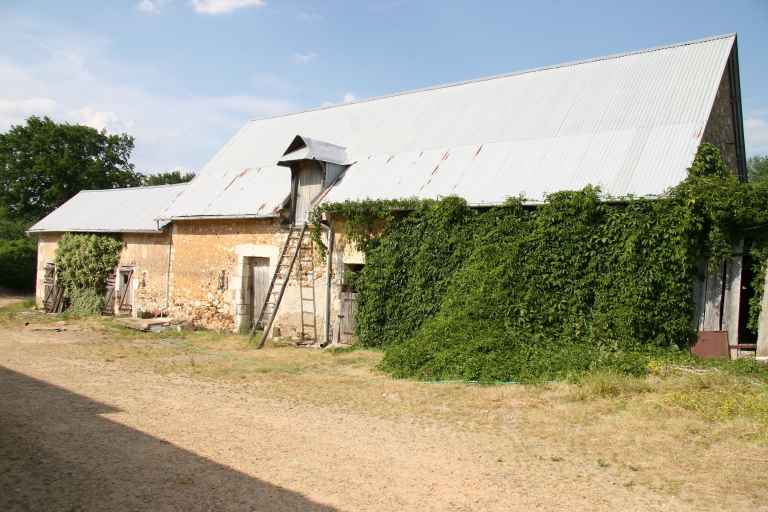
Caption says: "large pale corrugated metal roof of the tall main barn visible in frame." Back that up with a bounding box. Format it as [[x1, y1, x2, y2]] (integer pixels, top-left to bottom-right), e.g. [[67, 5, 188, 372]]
[[168, 35, 736, 218]]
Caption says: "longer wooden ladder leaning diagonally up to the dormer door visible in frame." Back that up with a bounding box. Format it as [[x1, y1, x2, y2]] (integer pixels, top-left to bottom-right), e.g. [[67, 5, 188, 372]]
[[251, 224, 307, 348]]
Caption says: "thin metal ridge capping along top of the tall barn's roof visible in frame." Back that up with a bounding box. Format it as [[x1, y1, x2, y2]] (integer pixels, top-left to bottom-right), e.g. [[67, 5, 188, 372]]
[[249, 32, 737, 124]]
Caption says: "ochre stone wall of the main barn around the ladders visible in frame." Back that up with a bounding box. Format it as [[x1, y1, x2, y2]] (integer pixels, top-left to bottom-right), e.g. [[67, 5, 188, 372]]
[[170, 219, 325, 339]]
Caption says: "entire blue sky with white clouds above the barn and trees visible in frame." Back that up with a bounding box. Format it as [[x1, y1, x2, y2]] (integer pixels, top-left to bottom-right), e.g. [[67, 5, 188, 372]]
[[0, 0, 768, 171]]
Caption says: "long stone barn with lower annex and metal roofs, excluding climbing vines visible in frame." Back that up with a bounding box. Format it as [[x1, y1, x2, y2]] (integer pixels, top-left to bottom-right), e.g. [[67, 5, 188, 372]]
[[30, 34, 760, 355]]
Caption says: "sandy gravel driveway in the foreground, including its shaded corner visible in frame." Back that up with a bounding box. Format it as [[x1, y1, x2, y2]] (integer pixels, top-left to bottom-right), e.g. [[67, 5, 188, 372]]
[[0, 320, 760, 511]]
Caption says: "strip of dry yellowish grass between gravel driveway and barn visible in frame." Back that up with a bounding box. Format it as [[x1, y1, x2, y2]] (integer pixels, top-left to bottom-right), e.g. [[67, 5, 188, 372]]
[[0, 302, 768, 508]]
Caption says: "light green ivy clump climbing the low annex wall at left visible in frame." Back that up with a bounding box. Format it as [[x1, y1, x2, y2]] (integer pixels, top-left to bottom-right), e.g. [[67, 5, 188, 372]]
[[55, 233, 123, 314]]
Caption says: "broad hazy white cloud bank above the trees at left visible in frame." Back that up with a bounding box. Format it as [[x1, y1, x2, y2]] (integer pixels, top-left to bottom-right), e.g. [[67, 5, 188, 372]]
[[0, 20, 300, 171]]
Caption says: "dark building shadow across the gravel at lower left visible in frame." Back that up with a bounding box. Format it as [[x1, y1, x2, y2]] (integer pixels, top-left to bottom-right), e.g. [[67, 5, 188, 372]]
[[0, 366, 335, 511]]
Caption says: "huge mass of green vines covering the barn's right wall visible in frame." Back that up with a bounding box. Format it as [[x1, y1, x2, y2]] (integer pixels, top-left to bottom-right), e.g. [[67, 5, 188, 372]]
[[315, 145, 768, 381]]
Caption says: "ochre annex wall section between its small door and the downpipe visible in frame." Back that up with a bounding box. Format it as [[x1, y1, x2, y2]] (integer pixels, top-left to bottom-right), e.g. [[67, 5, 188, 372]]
[[118, 232, 170, 316]]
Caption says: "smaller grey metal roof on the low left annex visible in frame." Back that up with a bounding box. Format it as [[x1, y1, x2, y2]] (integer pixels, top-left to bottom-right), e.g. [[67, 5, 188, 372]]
[[29, 183, 187, 233]]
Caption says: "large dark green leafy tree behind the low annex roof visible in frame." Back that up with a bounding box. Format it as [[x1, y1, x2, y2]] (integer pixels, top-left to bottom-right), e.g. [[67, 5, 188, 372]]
[[0, 116, 141, 220]]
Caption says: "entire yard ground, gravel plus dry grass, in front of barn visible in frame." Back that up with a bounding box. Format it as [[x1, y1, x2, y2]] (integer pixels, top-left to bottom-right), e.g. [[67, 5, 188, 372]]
[[0, 300, 768, 511]]
